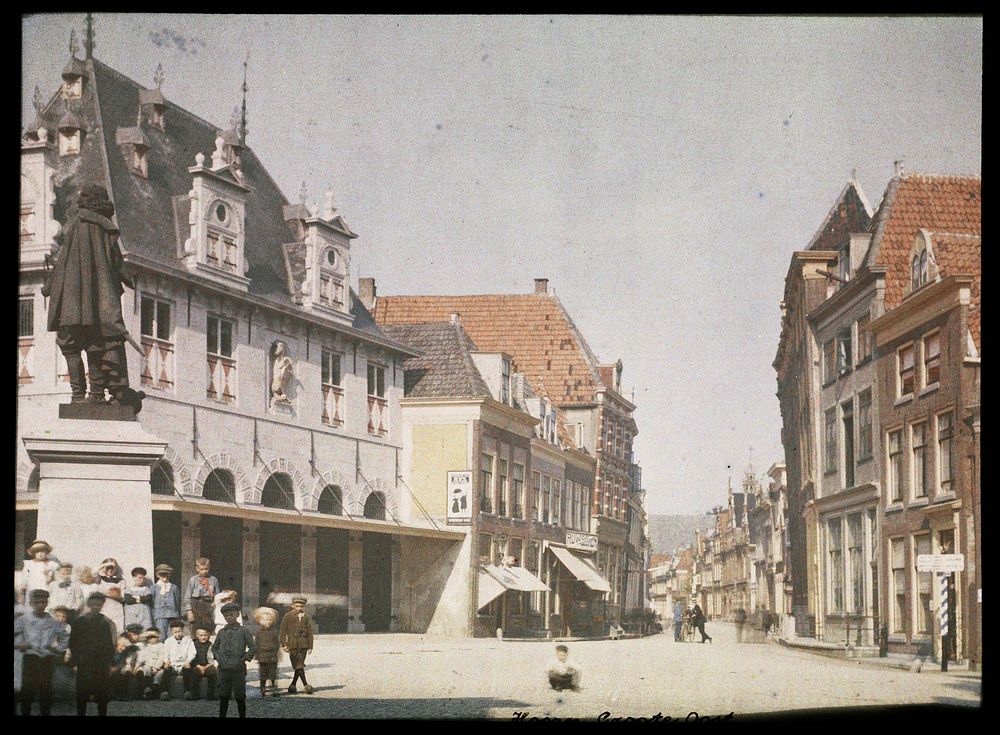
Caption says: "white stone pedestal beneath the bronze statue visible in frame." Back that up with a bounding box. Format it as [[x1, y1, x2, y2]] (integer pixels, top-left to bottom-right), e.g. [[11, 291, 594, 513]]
[[23, 419, 167, 576]]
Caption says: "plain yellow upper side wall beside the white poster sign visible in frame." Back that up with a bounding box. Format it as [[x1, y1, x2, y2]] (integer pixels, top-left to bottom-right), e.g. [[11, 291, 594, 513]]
[[411, 424, 472, 518]]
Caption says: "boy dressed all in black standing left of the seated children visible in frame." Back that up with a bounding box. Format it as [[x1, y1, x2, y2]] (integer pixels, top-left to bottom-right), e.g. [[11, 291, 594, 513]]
[[69, 592, 115, 717]]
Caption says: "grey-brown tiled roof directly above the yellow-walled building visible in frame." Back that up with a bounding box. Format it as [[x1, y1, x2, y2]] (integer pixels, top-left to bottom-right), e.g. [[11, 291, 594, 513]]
[[382, 322, 490, 398]]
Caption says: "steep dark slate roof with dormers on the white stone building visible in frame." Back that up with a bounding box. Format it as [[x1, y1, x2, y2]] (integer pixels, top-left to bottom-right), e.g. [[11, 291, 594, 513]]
[[34, 54, 404, 348]]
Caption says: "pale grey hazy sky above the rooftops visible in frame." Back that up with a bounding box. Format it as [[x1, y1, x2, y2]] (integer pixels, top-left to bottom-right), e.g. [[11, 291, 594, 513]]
[[22, 13, 983, 513]]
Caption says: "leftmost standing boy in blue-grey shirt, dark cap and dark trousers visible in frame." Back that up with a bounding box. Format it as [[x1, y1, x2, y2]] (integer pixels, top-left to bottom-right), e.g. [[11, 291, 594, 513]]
[[14, 589, 69, 717]]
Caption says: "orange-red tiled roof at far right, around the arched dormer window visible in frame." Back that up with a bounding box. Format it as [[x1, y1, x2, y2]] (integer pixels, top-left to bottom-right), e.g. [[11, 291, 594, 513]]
[[865, 174, 982, 311]]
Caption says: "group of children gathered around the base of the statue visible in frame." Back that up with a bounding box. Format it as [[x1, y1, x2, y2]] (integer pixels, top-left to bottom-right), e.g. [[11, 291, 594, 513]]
[[14, 541, 313, 717]]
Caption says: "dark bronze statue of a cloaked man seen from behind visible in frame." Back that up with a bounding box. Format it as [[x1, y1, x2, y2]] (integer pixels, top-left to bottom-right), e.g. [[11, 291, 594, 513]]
[[42, 184, 143, 412]]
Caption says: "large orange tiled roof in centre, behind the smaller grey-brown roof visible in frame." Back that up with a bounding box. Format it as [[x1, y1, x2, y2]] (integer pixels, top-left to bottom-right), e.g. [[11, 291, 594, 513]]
[[375, 294, 604, 406]]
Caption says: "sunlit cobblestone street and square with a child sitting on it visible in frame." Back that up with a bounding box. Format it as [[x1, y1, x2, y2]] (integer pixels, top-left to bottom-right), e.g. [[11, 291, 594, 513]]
[[37, 623, 981, 719]]
